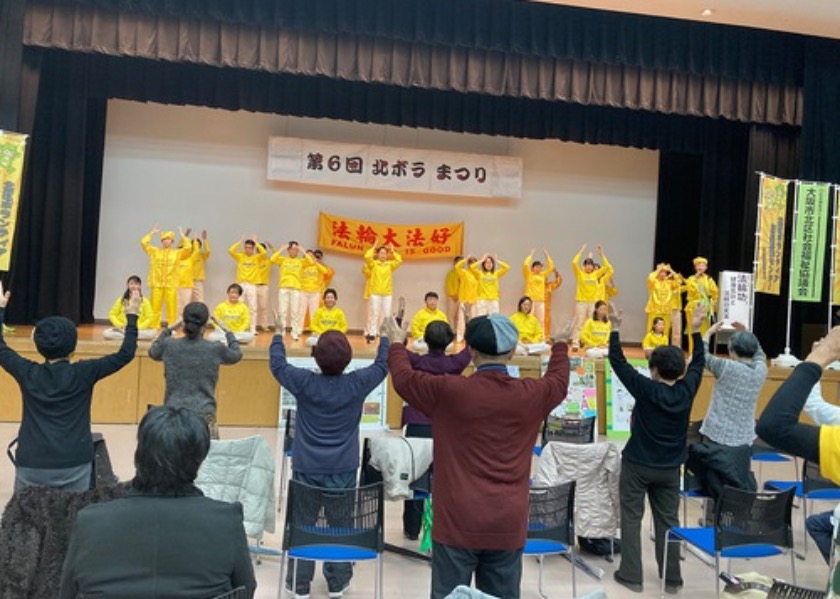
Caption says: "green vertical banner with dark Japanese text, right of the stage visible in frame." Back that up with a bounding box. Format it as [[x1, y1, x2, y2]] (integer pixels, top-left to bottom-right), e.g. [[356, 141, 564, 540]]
[[790, 182, 830, 302]]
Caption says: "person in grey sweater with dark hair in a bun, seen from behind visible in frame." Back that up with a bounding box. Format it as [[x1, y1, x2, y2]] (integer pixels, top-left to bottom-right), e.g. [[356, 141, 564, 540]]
[[149, 302, 242, 439]]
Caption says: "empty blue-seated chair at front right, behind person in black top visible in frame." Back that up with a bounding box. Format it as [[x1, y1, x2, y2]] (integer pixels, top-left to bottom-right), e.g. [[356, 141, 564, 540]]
[[660, 487, 796, 597]]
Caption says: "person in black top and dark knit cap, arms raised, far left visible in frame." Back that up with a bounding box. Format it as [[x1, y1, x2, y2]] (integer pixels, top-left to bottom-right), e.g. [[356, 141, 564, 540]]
[[0, 288, 140, 491]]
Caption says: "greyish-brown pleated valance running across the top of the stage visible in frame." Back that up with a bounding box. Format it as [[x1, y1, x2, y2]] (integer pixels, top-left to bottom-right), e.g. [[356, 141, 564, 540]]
[[24, 4, 802, 125]]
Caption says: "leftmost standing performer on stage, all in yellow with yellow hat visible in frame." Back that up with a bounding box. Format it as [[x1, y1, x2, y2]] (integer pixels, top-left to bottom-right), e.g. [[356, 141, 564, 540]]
[[140, 225, 192, 329]]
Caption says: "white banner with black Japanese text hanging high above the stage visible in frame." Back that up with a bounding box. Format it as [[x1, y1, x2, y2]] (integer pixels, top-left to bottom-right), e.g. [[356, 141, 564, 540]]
[[268, 137, 522, 198]]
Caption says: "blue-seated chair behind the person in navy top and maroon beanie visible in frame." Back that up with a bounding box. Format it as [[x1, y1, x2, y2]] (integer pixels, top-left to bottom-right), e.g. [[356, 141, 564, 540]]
[[277, 480, 385, 599]]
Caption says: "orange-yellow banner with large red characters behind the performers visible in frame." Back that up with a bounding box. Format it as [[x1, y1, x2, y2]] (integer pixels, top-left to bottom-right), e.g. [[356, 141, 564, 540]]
[[318, 212, 464, 260]]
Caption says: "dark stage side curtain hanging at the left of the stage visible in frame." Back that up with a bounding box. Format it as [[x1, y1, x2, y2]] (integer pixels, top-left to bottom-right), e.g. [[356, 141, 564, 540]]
[[8, 50, 106, 323]]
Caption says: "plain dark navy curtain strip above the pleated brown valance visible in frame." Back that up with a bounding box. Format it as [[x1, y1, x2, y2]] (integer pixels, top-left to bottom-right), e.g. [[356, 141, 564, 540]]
[[37, 0, 805, 85]]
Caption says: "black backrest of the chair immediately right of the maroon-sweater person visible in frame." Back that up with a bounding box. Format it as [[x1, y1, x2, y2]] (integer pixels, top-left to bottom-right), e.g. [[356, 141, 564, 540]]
[[528, 480, 575, 545]]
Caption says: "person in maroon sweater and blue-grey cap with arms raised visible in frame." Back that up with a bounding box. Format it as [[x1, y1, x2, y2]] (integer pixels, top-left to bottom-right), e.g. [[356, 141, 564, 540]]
[[383, 314, 570, 599]]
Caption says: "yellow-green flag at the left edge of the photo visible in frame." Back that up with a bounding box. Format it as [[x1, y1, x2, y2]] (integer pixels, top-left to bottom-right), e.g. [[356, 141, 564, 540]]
[[0, 129, 28, 270]]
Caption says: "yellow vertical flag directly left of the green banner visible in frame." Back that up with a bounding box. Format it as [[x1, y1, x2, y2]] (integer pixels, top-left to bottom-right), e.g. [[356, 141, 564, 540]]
[[755, 175, 789, 295]]
